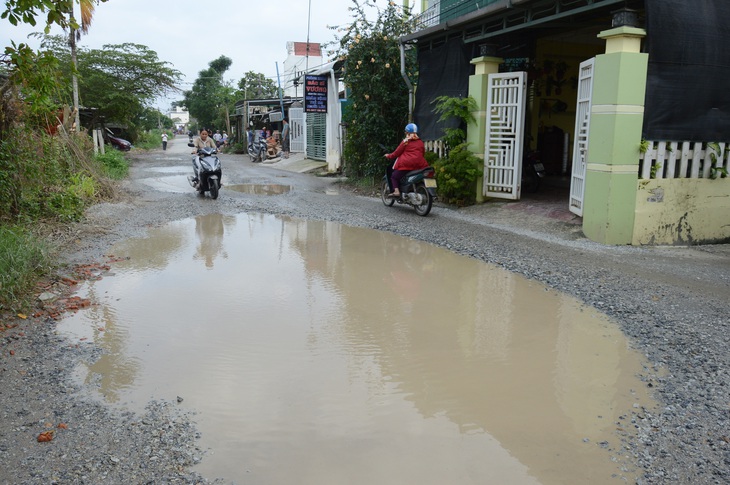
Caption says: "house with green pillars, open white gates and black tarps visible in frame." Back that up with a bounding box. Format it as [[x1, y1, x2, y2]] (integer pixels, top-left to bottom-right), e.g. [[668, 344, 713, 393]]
[[401, 0, 730, 245]]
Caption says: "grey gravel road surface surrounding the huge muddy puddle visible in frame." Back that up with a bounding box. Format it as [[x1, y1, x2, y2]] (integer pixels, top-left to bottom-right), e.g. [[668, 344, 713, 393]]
[[0, 145, 730, 484]]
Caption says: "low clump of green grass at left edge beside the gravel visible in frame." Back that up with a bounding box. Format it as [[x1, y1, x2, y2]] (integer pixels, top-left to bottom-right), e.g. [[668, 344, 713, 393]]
[[0, 226, 53, 311]]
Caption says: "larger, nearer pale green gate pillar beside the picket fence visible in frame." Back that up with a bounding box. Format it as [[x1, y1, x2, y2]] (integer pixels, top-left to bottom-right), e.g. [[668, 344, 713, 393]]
[[583, 27, 648, 244]]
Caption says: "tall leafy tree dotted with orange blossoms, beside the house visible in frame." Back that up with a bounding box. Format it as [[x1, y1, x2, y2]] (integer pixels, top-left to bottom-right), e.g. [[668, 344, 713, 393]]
[[336, 0, 416, 177]]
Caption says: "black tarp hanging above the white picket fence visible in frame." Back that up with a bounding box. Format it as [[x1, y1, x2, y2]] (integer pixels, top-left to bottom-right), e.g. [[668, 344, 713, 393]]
[[643, 0, 730, 141]]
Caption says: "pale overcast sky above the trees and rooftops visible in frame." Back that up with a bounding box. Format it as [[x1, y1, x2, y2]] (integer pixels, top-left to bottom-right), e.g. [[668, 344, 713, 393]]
[[0, 0, 410, 111]]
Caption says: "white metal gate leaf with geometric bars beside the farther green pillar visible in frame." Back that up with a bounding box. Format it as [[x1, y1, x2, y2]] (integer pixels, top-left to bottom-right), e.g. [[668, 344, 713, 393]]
[[483, 72, 527, 200]]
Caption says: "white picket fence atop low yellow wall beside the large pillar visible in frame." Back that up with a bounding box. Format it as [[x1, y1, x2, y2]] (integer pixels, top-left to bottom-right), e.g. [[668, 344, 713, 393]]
[[639, 141, 730, 179]]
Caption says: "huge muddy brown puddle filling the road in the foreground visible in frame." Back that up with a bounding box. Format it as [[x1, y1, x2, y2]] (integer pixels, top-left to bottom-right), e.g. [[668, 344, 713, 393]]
[[55, 214, 652, 484]]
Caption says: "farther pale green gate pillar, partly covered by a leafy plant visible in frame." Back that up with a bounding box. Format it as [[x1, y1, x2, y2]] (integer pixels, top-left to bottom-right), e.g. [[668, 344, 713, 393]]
[[466, 56, 504, 202]]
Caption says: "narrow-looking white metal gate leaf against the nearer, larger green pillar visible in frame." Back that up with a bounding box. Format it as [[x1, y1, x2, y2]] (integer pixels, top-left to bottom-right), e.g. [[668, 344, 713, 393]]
[[568, 58, 595, 216]]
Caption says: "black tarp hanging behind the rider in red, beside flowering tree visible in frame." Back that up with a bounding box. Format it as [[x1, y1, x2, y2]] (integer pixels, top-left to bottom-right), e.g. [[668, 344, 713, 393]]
[[413, 38, 472, 140]]
